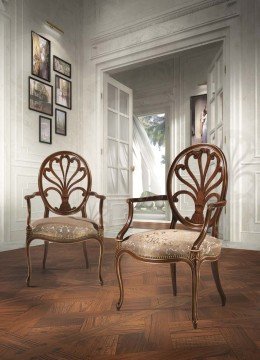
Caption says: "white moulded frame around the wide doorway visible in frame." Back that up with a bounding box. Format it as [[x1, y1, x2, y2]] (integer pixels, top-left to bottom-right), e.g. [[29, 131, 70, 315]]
[[92, 19, 240, 241]]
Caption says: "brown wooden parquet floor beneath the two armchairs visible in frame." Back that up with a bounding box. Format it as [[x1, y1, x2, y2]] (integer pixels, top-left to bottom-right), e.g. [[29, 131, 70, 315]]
[[0, 240, 260, 360]]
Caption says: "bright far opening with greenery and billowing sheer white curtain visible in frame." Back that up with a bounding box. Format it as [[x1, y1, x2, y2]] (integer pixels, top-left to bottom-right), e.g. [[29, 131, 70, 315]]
[[133, 113, 166, 220]]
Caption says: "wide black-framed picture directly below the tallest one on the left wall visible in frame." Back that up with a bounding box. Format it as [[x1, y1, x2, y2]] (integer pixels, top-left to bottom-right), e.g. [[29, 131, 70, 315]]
[[29, 76, 53, 116]]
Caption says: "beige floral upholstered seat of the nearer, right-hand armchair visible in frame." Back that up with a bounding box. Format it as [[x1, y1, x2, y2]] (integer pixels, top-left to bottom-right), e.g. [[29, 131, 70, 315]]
[[121, 229, 221, 260]]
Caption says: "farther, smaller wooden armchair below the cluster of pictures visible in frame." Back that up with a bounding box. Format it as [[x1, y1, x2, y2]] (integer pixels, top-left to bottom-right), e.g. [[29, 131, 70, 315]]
[[25, 151, 105, 286]]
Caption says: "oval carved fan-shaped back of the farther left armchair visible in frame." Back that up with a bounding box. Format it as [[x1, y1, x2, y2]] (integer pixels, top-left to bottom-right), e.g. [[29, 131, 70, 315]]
[[38, 151, 92, 215]]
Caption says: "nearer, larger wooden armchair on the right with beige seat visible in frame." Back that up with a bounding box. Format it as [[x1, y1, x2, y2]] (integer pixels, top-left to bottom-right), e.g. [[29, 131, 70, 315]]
[[115, 144, 228, 329]]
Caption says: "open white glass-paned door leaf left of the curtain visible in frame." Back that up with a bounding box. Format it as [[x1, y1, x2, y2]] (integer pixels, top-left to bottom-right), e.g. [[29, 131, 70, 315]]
[[104, 74, 133, 229]]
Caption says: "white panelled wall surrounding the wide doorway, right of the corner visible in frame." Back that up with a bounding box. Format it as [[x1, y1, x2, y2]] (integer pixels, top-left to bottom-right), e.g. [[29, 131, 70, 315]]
[[84, 0, 260, 246]]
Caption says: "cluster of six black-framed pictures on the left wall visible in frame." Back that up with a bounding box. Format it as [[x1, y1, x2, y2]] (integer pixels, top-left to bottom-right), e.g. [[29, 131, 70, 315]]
[[28, 31, 72, 144]]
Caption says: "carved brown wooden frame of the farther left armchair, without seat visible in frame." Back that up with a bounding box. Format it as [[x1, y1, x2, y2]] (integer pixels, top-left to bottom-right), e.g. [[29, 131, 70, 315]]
[[25, 151, 106, 286]]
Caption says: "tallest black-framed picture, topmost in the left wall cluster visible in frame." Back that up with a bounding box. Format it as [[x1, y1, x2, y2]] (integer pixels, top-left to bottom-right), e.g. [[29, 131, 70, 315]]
[[32, 31, 51, 81]]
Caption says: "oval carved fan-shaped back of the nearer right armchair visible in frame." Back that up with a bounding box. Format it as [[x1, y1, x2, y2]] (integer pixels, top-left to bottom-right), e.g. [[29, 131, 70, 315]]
[[167, 144, 227, 236]]
